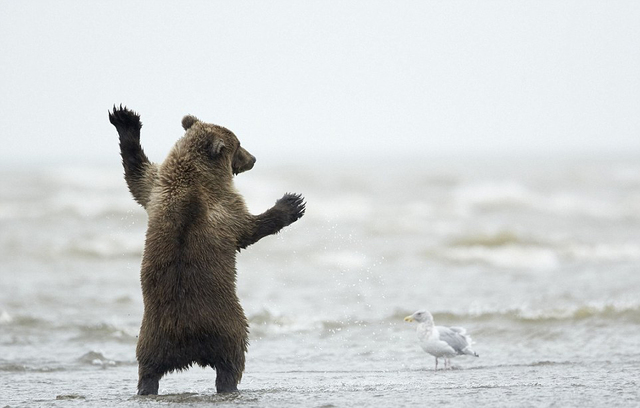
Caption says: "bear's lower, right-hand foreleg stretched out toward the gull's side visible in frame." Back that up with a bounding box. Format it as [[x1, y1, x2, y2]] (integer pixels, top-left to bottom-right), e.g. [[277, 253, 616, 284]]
[[238, 193, 306, 250]]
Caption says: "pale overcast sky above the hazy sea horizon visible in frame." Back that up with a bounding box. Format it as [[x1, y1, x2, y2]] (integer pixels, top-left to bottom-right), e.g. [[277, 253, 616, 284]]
[[0, 0, 640, 164]]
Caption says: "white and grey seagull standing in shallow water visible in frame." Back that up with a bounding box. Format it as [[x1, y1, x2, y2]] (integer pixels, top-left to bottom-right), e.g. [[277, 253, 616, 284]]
[[404, 310, 480, 370]]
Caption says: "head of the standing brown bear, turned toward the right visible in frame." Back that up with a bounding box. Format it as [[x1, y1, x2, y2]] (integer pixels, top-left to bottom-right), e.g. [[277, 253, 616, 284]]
[[176, 115, 256, 175]]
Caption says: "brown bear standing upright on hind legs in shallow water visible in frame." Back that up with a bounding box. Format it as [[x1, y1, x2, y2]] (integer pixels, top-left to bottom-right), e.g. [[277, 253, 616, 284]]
[[109, 106, 305, 395]]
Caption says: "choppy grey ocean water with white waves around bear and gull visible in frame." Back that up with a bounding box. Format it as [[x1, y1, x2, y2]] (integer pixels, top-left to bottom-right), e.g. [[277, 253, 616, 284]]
[[0, 157, 640, 407]]
